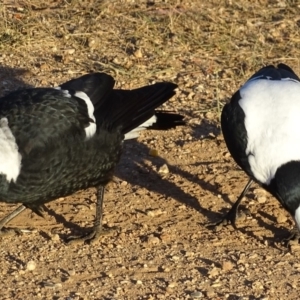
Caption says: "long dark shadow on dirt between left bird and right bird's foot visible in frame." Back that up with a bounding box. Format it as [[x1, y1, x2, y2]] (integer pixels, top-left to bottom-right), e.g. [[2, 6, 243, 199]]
[[115, 140, 227, 218]]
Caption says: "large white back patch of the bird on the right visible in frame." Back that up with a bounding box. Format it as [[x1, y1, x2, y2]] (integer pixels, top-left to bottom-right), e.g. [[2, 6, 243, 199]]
[[239, 79, 300, 184]]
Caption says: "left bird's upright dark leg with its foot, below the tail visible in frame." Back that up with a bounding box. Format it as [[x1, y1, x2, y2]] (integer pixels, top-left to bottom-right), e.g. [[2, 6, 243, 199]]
[[66, 185, 114, 244]]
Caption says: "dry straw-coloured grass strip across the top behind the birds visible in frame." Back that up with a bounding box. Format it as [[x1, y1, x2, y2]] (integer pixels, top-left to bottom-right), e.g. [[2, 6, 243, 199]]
[[0, 0, 300, 119]]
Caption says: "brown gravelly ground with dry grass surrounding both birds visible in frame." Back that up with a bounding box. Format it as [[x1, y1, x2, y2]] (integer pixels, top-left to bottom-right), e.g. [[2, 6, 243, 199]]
[[0, 0, 300, 300]]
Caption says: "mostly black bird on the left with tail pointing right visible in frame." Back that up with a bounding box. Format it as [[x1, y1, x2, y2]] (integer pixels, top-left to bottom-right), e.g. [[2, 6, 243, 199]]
[[0, 73, 184, 241]]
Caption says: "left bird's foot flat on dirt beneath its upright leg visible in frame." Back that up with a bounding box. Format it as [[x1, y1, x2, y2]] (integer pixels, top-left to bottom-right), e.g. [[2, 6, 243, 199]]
[[65, 227, 117, 245]]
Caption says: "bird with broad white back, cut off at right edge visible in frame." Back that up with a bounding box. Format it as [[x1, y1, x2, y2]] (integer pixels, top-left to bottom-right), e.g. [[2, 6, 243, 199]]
[[219, 64, 300, 244]]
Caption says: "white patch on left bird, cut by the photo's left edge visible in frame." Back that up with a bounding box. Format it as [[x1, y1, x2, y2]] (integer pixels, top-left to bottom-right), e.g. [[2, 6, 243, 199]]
[[0, 118, 22, 182]]
